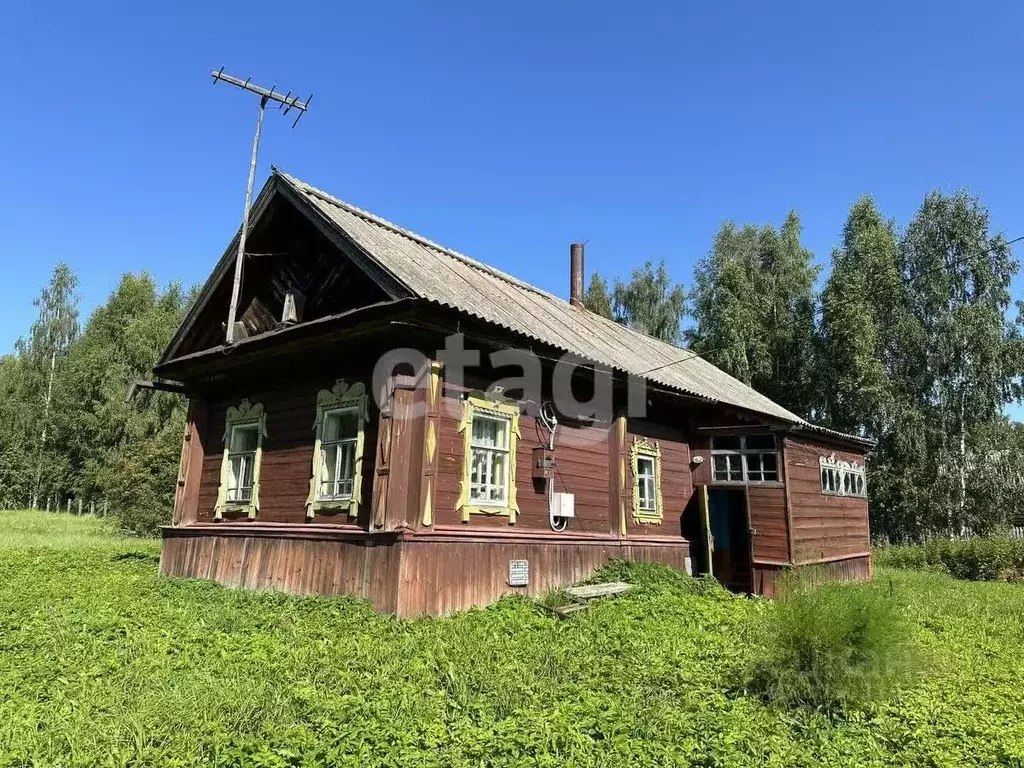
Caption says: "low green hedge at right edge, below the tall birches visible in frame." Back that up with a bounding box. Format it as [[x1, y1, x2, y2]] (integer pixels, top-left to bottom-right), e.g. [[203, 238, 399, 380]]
[[874, 537, 1024, 581]]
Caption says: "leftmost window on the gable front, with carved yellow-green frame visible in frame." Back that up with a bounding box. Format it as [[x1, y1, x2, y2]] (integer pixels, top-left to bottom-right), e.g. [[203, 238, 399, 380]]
[[213, 400, 266, 520]]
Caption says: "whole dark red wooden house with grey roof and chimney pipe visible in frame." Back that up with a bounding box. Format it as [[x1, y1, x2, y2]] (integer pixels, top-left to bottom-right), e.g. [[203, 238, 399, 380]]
[[156, 170, 870, 616]]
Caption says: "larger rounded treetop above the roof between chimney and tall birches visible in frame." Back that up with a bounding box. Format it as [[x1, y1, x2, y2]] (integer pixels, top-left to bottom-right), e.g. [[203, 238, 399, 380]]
[[612, 261, 686, 344]]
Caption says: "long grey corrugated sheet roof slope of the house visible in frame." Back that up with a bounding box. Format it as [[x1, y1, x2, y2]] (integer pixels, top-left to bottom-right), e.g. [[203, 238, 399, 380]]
[[275, 171, 806, 424]]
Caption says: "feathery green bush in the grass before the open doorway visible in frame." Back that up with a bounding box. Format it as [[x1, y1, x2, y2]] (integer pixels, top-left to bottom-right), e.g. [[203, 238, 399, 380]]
[[749, 574, 921, 715]]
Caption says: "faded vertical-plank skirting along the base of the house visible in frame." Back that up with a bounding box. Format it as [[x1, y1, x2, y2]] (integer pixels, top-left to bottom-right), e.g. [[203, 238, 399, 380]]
[[160, 523, 689, 616]]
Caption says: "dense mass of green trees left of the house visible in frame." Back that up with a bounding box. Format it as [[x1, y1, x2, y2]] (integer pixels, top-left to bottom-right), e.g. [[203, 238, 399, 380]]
[[0, 265, 191, 534]]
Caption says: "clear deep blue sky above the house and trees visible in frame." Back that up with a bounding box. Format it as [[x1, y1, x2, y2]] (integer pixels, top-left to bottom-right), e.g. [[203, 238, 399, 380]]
[[0, 1, 1024, 352]]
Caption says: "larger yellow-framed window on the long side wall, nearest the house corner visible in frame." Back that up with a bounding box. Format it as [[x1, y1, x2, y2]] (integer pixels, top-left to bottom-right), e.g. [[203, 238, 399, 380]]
[[457, 394, 519, 522]]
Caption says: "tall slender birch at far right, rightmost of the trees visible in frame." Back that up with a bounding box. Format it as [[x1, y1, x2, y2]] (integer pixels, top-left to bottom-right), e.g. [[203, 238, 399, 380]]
[[899, 191, 1021, 535]]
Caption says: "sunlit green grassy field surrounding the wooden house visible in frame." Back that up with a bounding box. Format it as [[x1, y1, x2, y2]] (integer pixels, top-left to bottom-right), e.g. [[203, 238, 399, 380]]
[[0, 512, 1024, 768]]
